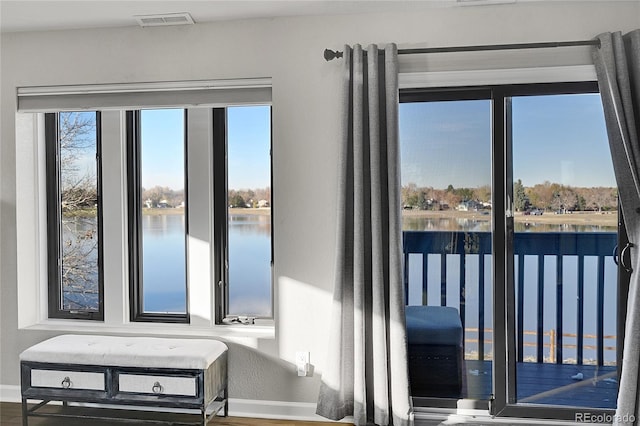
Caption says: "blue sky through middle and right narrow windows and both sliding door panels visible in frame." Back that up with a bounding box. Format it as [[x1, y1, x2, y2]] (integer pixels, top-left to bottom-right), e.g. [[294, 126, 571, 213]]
[[142, 94, 615, 193]]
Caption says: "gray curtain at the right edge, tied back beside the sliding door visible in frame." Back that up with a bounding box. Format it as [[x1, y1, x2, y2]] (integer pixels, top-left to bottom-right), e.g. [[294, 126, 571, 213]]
[[593, 30, 640, 424]]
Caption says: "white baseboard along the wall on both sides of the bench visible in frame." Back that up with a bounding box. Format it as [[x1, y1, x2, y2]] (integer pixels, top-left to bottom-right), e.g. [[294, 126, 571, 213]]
[[0, 385, 353, 423]]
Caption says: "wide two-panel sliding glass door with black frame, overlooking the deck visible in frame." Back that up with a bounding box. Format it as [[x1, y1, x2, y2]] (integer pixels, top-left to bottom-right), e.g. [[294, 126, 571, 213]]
[[400, 83, 626, 420]]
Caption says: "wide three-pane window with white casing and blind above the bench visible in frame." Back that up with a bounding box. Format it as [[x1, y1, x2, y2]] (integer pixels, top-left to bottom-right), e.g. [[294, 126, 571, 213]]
[[16, 78, 273, 328]]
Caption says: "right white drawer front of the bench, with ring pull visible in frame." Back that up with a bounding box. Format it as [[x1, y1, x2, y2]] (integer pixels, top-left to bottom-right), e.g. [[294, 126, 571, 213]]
[[118, 373, 197, 397]]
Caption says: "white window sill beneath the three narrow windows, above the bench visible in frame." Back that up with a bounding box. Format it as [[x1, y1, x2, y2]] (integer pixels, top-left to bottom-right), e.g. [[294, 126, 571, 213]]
[[21, 319, 275, 341]]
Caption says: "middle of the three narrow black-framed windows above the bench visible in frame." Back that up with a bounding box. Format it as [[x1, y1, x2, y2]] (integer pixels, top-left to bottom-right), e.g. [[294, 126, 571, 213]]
[[128, 109, 189, 322]]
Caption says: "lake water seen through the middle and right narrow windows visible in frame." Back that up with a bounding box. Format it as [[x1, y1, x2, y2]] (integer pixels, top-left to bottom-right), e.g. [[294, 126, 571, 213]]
[[142, 213, 272, 317]]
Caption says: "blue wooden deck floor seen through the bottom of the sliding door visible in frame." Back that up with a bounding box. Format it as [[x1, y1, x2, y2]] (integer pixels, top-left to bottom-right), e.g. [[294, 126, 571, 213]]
[[463, 360, 618, 408]]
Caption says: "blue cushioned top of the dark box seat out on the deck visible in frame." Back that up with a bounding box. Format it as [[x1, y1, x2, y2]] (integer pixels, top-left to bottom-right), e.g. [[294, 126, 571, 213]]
[[406, 306, 462, 346]]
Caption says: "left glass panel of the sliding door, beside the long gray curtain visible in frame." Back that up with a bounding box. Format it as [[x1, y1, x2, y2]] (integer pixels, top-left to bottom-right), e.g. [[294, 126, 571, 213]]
[[400, 91, 493, 407]]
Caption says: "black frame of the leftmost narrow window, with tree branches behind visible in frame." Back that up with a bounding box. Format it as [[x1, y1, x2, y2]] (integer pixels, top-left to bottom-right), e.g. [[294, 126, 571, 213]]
[[44, 111, 104, 321]]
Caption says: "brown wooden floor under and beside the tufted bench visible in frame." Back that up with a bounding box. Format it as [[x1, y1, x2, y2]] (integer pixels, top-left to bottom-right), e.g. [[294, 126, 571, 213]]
[[0, 402, 348, 426]]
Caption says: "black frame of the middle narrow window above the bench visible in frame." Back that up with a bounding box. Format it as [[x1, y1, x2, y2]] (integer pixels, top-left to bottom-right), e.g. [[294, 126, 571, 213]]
[[125, 109, 191, 324]]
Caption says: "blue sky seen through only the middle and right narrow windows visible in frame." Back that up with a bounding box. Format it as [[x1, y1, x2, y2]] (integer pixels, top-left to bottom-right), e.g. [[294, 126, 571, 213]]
[[141, 106, 271, 189]]
